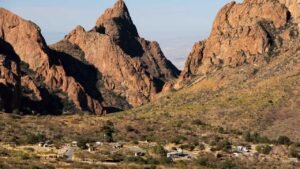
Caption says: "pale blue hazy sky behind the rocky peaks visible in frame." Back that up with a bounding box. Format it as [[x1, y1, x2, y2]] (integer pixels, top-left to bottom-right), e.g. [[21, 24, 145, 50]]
[[0, 0, 241, 68]]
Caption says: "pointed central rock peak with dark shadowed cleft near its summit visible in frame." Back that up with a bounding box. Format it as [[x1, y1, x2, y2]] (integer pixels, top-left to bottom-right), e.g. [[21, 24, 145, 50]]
[[64, 0, 179, 106]]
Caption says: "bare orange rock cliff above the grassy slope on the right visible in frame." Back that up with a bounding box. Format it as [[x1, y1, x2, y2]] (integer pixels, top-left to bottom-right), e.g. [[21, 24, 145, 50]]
[[181, 0, 300, 79]]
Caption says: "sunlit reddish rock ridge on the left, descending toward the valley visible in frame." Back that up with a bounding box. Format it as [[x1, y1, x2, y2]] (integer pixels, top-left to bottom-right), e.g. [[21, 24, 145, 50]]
[[0, 8, 103, 114]]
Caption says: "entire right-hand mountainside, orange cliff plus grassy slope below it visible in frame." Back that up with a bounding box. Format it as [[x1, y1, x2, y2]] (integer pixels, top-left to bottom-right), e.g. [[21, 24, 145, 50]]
[[159, 0, 300, 140]]
